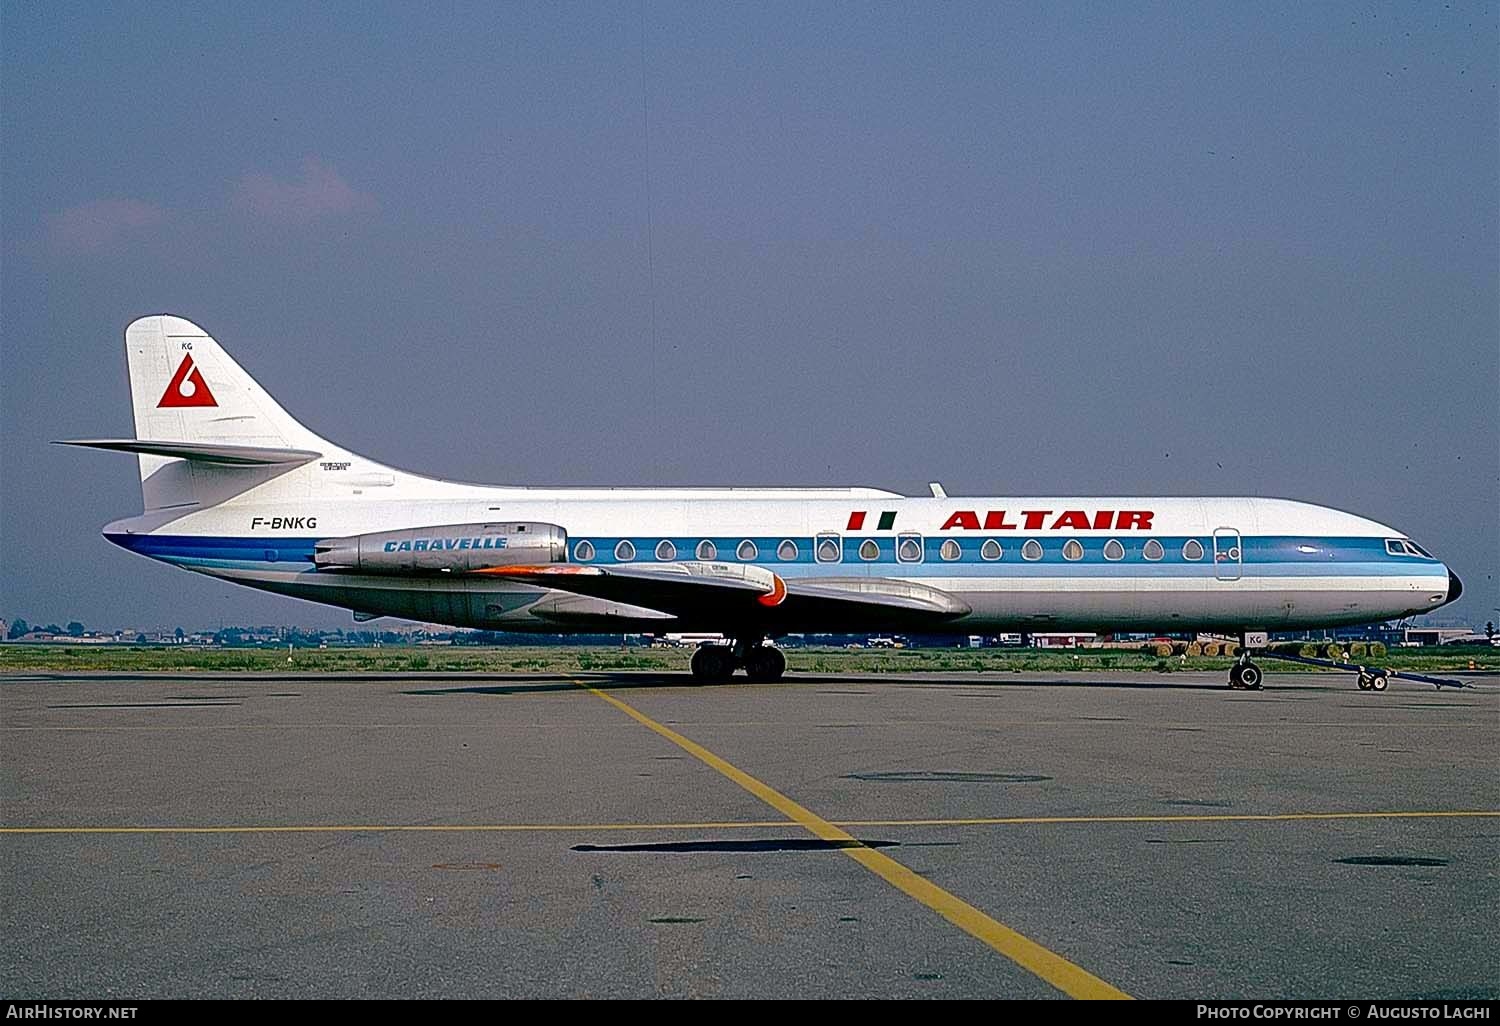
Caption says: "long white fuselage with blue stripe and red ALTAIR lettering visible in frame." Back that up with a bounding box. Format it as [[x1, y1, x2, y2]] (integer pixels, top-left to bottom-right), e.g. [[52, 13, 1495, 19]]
[[107, 486, 1449, 633]]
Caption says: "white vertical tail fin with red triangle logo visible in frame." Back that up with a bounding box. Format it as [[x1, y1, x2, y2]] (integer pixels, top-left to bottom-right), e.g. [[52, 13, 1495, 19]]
[[125, 315, 344, 510]]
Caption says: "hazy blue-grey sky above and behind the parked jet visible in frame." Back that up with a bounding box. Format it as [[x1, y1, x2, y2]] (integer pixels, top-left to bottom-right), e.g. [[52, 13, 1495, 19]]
[[0, 2, 1500, 626]]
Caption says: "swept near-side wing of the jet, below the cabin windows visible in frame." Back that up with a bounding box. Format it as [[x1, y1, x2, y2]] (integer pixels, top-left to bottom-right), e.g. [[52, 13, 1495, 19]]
[[474, 561, 971, 633]]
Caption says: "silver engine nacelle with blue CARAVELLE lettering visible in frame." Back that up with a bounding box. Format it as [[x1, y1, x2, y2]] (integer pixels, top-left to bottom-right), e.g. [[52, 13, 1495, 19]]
[[312, 524, 567, 573]]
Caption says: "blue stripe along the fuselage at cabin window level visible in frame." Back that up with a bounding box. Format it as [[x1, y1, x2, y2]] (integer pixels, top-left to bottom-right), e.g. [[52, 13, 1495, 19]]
[[108, 533, 1445, 578]]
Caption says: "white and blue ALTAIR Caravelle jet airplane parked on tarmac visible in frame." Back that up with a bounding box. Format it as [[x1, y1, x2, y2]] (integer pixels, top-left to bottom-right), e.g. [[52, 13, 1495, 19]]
[[60, 315, 1463, 690]]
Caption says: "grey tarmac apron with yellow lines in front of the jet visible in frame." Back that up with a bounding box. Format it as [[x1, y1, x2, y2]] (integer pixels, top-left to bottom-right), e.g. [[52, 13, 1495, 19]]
[[0, 674, 1500, 999]]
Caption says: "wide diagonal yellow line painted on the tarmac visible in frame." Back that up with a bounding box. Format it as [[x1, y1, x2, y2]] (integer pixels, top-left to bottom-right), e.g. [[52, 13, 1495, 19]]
[[575, 681, 1130, 999]]
